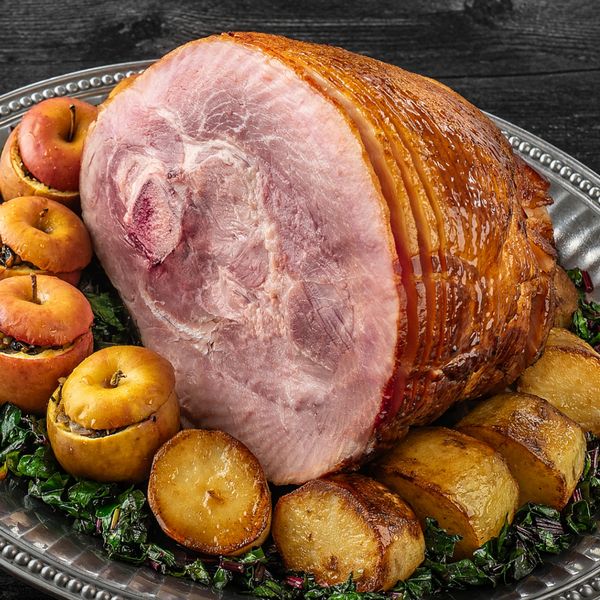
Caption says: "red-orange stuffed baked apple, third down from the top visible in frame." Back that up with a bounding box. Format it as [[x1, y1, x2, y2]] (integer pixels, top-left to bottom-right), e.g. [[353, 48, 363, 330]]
[[0, 275, 94, 413]]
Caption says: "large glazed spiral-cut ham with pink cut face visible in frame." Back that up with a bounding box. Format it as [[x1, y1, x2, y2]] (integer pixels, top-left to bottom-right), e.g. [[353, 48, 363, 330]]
[[81, 33, 555, 483]]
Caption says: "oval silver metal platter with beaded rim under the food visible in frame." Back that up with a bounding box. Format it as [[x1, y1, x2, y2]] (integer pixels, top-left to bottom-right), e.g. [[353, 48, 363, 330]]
[[0, 61, 600, 600]]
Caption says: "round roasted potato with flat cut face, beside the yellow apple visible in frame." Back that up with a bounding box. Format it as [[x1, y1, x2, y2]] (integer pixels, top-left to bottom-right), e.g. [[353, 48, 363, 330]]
[[148, 429, 271, 555]]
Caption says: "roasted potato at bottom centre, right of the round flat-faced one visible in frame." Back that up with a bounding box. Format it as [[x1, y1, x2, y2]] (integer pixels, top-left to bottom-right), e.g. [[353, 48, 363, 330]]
[[273, 474, 425, 592]]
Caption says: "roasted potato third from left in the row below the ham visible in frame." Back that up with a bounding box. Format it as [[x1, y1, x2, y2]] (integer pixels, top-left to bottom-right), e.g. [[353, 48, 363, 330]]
[[371, 427, 519, 558]]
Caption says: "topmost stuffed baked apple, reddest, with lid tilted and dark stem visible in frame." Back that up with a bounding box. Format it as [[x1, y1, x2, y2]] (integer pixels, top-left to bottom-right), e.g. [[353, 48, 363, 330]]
[[0, 97, 98, 208]]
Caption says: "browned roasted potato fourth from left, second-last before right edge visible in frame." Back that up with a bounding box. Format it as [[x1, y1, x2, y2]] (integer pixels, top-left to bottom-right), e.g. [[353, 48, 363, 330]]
[[457, 393, 586, 510]]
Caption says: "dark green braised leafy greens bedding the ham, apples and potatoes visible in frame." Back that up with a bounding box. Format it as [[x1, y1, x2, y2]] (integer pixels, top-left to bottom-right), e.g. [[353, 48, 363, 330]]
[[0, 264, 600, 600]]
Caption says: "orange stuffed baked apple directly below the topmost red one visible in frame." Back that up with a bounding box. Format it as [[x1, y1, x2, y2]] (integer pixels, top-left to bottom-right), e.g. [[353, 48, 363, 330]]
[[0, 196, 92, 285]]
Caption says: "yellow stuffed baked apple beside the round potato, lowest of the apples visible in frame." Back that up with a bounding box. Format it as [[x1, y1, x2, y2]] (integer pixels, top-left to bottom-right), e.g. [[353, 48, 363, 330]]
[[46, 346, 179, 482]]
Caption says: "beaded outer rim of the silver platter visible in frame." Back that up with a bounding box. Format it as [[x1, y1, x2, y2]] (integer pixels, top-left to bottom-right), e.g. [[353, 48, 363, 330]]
[[0, 61, 600, 600]]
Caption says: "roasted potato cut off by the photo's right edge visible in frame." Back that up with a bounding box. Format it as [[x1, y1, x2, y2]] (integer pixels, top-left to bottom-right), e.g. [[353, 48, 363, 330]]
[[517, 328, 600, 435]]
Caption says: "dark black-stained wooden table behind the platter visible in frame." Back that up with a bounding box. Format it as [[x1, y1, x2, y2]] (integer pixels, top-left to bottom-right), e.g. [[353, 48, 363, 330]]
[[0, 0, 600, 599]]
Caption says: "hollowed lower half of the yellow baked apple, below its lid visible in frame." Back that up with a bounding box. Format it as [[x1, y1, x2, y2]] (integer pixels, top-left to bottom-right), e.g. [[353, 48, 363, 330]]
[[46, 390, 180, 483]]
